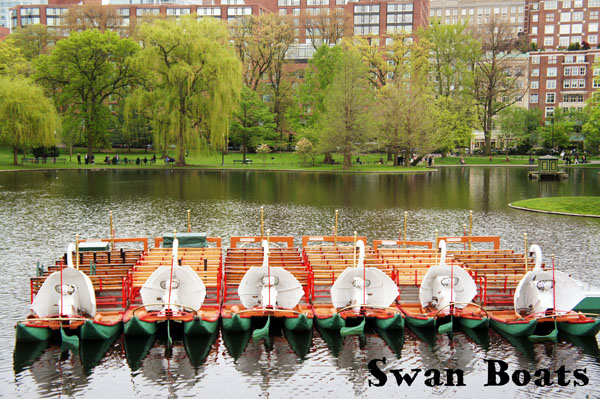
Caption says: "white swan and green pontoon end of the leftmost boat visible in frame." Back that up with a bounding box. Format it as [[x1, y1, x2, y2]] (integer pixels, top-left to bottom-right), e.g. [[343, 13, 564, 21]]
[[16, 244, 123, 346]]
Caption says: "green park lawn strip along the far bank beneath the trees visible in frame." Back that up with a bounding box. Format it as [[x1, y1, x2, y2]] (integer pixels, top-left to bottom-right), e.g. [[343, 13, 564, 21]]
[[0, 148, 426, 172]]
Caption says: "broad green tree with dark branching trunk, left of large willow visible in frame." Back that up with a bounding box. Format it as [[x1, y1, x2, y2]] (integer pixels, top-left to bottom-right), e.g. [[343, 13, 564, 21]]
[[35, 30, 139, 157]]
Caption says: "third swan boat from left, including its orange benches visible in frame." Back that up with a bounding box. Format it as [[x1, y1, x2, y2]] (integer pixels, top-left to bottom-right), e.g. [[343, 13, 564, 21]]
[[221, 237, 313, 339]]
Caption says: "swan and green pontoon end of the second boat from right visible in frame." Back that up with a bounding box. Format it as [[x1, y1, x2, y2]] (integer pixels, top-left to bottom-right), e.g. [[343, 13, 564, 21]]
[[398, 240, 489, 333]]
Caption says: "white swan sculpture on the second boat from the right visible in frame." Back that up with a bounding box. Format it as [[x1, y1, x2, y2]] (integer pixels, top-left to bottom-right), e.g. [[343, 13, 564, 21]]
[[419, 240, 477, 310]]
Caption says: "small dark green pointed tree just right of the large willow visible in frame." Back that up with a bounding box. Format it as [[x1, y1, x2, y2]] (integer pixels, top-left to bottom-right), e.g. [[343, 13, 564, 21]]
[[231, 86, 276, 161]]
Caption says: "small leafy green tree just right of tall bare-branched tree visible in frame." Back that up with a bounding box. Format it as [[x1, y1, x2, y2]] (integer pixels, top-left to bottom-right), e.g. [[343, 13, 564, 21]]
[[498, 106, 542, 147]]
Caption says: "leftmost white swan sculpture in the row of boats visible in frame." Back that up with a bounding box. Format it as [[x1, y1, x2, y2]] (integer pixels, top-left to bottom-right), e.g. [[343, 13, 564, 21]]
[[31, 243, 96, 318]]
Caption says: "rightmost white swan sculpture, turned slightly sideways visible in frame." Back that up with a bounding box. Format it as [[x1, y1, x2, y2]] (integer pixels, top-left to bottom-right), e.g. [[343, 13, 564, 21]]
[[514, 244, 585, 316]]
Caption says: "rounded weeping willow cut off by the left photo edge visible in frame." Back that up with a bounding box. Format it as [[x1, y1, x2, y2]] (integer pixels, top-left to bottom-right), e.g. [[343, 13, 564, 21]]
[[0, 77, 59, 165]]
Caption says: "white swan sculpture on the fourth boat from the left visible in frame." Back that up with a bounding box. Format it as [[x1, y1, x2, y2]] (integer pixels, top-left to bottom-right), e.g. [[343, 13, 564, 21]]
[[331, 240, 399, 309]]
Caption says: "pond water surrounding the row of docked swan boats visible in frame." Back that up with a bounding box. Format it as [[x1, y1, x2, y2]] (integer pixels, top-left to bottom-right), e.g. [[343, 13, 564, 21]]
[[0, 167, 600, 398]]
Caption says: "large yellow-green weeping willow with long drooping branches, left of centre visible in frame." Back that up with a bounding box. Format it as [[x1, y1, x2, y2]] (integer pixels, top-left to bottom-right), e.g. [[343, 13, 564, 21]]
[[125, 15, 241, 166]]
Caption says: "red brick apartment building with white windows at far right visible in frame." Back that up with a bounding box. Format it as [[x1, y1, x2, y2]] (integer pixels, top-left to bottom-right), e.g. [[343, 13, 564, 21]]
[[525, 0, 600, 120]]
